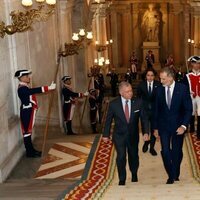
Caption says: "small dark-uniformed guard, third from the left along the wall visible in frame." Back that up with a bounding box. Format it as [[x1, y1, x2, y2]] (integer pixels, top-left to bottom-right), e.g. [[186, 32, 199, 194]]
[[89, 89, 98, 133]]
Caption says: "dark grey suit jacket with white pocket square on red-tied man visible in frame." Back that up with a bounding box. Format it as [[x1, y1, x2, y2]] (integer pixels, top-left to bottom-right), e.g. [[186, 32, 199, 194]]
[[103, 97, 148, 144]]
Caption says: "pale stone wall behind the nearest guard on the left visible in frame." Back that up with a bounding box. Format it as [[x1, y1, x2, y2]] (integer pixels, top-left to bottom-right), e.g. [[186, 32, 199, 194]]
[[0, 0, 59, 182]]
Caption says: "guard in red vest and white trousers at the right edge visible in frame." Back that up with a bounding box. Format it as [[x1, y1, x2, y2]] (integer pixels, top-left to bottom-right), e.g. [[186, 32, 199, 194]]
[[183, 56, 200, 139]]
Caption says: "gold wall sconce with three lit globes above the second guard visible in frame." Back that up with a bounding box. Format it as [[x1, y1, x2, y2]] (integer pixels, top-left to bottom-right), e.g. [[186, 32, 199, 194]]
[[58, 29, 93, 57]]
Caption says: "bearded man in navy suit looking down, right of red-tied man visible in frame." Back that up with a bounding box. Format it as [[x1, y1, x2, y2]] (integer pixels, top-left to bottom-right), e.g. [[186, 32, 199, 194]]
[[153, 67, 192, 184]]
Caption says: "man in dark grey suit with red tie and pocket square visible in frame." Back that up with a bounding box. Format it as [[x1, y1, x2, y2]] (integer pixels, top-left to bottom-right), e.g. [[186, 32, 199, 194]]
[[103, 81, 149, 185]]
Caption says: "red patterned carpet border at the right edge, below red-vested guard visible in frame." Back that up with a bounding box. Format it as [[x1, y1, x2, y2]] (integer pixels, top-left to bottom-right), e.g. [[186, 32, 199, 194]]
[[185, 133, 200, 183]]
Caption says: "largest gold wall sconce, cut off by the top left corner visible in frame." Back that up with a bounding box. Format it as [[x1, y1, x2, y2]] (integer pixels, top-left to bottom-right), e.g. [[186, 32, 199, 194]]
[[0, 0, 56, 38]]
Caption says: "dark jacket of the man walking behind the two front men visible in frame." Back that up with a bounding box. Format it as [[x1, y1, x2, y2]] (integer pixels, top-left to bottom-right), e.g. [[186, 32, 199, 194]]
[[137, 80, 161, 111]]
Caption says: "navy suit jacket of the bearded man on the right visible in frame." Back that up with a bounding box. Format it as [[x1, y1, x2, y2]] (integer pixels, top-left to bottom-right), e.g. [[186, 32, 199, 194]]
[[153, 83, 192, 134]]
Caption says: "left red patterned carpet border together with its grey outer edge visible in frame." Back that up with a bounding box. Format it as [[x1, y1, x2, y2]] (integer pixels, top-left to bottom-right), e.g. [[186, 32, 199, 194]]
[[57, 99, 116, 200]]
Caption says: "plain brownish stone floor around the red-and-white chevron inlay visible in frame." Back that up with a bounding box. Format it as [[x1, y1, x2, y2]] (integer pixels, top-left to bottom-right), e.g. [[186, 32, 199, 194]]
[[0, 126, 95, 200]]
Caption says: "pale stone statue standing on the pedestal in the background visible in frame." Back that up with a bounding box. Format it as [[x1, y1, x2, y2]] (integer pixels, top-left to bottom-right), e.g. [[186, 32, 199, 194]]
[[142, 4, 160, 42]]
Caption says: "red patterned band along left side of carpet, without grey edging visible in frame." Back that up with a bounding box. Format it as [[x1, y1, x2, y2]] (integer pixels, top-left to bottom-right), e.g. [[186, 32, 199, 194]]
[[64, 138, 115, 200]]
